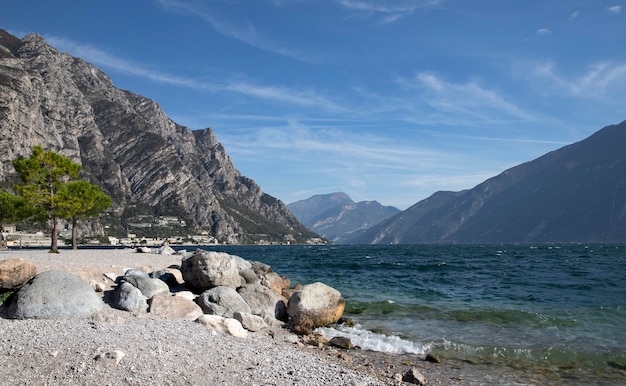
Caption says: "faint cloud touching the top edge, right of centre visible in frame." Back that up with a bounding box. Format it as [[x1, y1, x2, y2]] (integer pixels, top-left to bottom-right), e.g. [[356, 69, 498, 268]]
[[337, 0, 443, 24]]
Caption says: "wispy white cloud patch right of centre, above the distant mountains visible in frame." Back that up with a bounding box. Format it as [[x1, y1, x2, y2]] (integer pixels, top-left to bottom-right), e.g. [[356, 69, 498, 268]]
[[398, 72, 531, 126]]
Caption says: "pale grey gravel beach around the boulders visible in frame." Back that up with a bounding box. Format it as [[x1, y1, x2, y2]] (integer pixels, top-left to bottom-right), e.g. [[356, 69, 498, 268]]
[[0, 249, 568, 386]]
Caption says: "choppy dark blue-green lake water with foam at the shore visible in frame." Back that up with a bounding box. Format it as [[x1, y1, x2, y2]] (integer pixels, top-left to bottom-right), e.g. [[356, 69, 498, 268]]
[[199, 244, 626, 382]]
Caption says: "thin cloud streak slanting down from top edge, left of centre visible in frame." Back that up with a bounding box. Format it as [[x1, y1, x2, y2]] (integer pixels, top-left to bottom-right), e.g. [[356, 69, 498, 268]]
[[156, 0, 318, 63]]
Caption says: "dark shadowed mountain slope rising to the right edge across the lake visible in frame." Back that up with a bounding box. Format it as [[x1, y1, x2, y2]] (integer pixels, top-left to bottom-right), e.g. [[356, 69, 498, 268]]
[[349, 121, 626, 244]]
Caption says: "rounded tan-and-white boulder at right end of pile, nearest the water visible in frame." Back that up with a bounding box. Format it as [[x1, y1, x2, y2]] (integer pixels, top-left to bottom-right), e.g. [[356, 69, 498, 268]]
[[287, 282, 345, 333]]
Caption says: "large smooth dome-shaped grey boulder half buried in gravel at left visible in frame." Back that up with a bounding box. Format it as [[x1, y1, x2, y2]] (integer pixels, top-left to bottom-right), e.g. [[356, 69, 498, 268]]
[[7, 271, 104, 319]]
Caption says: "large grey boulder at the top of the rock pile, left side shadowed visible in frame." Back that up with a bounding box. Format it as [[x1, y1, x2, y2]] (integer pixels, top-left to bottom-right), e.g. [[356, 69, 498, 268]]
[[180, 249, 242, 291]]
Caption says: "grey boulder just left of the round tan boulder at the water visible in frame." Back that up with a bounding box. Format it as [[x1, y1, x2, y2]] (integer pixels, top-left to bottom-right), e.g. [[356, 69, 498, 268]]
[[237, 284, 287, 326]]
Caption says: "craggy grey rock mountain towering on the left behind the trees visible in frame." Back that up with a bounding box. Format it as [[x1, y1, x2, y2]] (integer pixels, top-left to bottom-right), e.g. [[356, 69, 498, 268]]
[[0, 30, 316, 243]]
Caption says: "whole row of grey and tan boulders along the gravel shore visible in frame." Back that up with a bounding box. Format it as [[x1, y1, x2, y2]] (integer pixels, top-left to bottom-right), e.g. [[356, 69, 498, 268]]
[[0, 249, 344, 337]]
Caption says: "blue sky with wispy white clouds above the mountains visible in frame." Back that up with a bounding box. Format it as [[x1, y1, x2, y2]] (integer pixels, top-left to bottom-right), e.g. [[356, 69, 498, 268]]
[[0, 0, 626, 209]]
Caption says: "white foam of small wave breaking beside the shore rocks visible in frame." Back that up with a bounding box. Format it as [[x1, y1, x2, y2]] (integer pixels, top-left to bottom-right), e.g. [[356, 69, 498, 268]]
[[315, 324, 432, 354]]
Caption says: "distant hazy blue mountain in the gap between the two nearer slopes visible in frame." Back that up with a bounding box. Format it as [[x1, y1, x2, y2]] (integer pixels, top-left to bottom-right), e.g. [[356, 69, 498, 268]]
[[287, 193, 400, 243]]
